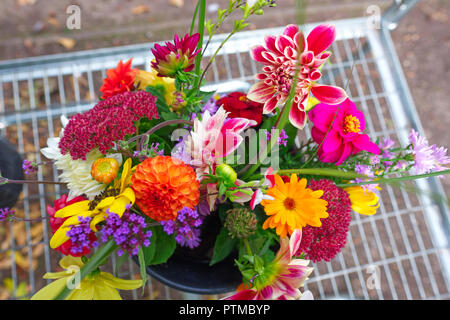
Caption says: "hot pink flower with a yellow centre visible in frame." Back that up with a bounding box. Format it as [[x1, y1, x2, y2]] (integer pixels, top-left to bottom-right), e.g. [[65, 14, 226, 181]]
[[308, 99, 380, 165]]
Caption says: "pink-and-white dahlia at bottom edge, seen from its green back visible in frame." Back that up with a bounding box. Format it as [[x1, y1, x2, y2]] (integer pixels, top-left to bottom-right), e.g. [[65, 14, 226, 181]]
[[226, 229, 313, 300]]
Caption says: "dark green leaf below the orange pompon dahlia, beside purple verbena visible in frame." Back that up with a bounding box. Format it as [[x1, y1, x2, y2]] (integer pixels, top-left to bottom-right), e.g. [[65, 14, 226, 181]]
[[142, 226, 177, 266]]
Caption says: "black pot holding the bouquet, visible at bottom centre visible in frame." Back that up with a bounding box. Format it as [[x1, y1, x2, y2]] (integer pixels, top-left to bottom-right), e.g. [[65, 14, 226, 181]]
[[134, 212, 242, 294]]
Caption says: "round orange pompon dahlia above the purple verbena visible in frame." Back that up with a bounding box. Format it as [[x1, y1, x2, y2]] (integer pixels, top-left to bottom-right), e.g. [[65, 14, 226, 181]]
[[131, 156, 200, 221]]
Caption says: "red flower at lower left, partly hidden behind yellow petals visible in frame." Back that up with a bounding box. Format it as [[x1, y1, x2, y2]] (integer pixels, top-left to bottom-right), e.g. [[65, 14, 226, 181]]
[[47, 194, 97, 257]]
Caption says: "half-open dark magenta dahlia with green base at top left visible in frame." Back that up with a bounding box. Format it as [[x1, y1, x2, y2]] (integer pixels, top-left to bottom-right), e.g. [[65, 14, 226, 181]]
[[152, 33, 201, 77]]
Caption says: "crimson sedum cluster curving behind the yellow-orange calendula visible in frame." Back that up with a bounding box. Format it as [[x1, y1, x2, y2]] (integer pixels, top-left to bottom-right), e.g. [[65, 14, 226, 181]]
[[296, 179, 352, 262]]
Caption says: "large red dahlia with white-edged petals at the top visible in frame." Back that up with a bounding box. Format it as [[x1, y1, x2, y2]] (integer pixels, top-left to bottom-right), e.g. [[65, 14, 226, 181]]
[[247, 24, 347, 129]]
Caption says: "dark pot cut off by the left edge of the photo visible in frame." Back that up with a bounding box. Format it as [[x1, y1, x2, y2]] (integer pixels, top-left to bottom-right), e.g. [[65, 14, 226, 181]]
[[0, 137, 24, 208]]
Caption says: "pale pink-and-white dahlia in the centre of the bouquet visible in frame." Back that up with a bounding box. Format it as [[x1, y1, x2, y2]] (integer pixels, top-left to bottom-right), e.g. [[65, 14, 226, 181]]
[[185, 107, 256, 178]]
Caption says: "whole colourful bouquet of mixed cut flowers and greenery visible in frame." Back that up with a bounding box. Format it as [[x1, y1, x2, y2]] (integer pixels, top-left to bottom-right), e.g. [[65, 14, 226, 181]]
[[0, 0, 450, 299]]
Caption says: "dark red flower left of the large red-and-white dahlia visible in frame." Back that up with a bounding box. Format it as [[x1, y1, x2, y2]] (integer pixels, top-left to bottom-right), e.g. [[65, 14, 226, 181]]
[[216, 91, 264, 125]]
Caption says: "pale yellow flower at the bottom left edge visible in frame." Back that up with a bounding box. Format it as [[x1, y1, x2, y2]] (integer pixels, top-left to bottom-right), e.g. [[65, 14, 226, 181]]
[[31, 256, 142, 300]]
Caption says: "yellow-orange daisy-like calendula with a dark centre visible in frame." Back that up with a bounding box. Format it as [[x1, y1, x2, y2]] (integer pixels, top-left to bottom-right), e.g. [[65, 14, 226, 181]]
[[261, 174, 328, 237]]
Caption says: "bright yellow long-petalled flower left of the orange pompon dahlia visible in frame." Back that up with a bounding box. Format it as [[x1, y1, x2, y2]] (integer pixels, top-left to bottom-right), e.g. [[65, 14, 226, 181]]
[[50, 158, 136, 249]]
